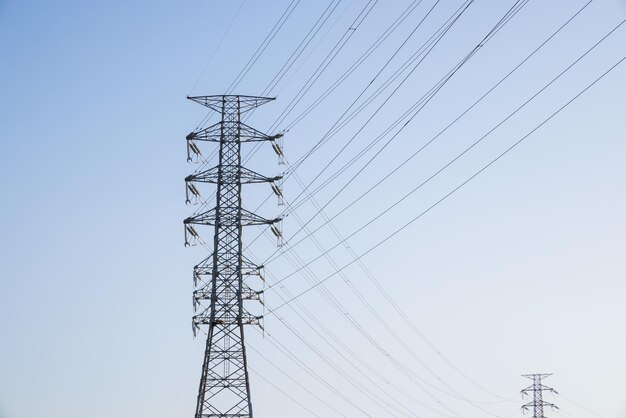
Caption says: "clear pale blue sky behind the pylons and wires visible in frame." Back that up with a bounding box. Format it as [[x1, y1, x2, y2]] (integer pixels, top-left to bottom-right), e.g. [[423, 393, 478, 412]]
[[0, 0, 626, 418]]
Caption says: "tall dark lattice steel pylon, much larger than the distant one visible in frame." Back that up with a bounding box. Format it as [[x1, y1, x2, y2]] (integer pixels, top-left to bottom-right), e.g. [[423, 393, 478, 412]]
[[184, 95, 282, 418]]
